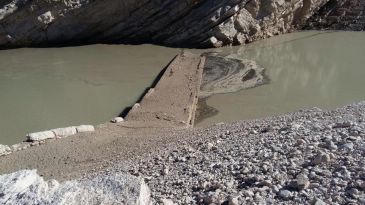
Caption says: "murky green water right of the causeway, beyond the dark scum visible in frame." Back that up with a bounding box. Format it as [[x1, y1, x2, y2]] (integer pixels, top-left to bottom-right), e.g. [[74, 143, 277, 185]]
[[198, 32, 365, 126]]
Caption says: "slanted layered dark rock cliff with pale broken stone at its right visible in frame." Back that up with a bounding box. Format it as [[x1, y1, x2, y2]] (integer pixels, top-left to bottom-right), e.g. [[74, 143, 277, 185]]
[[0, 0, 361, 47]]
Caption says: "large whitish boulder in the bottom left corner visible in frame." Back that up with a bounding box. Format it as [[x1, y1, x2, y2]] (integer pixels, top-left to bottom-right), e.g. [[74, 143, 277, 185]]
[[0, 170, 151, 205]]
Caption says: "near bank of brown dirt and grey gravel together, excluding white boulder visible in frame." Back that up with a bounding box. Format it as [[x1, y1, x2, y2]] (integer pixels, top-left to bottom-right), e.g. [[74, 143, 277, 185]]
[[0, 102, 365, 205]]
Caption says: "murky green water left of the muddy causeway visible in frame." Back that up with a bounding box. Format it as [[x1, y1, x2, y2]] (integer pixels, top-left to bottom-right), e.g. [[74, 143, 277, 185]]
[[0, 45, 179, 144]]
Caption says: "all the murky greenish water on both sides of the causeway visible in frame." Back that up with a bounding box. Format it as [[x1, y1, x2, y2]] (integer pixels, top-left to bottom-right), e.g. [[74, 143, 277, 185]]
[[0, 31, 365, 144]]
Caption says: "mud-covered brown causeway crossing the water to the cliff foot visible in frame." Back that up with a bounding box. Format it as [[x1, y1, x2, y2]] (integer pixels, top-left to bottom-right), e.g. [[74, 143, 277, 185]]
[[122, 53, 205, 129]]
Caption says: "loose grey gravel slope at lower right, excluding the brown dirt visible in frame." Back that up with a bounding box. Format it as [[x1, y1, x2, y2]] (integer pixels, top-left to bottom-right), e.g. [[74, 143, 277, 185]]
[[119, 102, 365, 205]]
